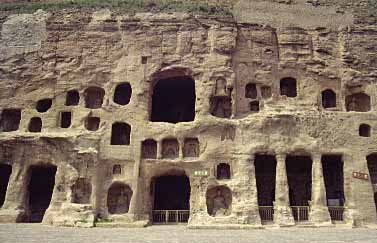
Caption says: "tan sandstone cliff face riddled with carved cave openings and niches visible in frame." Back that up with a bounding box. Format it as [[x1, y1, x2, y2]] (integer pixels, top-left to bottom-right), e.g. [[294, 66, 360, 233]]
[[0, 3, 377, 228]]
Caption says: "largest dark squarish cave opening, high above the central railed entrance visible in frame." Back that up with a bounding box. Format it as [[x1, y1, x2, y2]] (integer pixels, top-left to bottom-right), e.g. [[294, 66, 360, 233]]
[[150, 76, 196, 123]]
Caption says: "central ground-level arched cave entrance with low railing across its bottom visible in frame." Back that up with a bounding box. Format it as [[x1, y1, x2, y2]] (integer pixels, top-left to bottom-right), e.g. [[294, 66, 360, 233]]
[[151, 175, 191, 223]]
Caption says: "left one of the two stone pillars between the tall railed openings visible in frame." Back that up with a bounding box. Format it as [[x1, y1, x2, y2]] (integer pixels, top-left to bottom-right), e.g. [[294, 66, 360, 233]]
[[274, 154, 295, 226]]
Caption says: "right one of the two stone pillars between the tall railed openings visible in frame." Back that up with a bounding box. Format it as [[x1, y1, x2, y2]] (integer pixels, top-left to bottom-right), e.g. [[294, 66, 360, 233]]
[[309, 154, 331, 224]]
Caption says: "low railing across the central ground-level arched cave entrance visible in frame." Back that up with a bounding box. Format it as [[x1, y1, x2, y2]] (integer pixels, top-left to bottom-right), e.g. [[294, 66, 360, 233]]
[[152, 210, 190, 224]]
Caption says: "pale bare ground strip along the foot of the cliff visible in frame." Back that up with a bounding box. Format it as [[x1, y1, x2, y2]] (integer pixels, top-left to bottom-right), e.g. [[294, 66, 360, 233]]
[[0, 224, 377, 243]]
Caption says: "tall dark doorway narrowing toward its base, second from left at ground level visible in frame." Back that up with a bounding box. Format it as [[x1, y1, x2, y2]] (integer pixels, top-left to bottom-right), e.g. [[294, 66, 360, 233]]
[[28, 165, 57, 223]]
